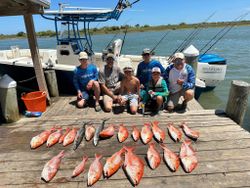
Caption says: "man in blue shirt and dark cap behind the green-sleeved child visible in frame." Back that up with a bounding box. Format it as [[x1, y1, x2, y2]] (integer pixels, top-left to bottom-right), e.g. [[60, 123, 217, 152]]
[[136, 48, 165, 102]]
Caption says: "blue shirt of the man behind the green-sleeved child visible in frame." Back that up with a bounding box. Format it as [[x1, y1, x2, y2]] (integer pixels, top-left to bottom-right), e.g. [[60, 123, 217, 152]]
[[136, 60, 165, 86]]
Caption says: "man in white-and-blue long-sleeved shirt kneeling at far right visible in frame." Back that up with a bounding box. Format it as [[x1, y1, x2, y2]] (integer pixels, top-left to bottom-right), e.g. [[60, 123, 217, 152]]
[[165, 53, 195, 112]]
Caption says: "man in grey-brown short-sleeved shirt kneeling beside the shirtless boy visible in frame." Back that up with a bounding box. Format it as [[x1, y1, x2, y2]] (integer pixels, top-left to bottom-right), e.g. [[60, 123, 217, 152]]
[[99, 53, 123, 112]]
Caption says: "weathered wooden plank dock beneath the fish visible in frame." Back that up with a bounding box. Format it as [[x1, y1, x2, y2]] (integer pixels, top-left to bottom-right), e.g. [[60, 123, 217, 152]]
[[0, 97, 250, 188]]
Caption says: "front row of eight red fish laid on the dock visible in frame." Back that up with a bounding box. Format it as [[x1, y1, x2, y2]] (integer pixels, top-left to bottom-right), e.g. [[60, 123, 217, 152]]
[[41, 140, 198, 186]]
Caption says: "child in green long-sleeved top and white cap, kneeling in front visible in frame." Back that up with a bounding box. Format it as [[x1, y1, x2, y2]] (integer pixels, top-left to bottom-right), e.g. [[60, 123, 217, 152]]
[[142, 67, 168, 114]]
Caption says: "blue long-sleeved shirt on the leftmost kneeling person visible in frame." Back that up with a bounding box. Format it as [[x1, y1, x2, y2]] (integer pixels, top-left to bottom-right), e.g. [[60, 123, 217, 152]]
[[73, 64, 98, 91]]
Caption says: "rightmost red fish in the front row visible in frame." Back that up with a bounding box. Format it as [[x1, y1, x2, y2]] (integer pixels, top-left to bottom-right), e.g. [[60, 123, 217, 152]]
[[180, 140, 198, 173]]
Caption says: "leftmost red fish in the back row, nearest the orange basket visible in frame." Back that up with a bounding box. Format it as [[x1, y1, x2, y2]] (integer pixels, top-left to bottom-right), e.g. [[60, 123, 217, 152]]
[[30, 127, 55, 149]]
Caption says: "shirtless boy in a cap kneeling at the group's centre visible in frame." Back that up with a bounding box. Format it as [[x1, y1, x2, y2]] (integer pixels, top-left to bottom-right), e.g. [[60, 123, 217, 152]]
[[118, 66, 140, 114]]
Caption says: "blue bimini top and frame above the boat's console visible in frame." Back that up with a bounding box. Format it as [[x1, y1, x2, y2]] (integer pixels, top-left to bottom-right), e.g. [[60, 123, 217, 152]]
[[42, 0, 139, 55]]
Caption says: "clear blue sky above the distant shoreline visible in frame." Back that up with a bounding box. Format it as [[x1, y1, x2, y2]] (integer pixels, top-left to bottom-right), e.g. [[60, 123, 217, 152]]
[[0, 0, 250, 34]]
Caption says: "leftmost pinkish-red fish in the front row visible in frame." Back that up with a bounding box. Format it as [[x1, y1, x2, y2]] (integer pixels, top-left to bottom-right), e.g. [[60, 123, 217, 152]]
[[41, 151, 65, 183]]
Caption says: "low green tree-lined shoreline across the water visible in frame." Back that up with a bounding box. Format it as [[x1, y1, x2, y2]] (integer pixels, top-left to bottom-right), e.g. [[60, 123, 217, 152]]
[[0, 20, 250, 39]]
